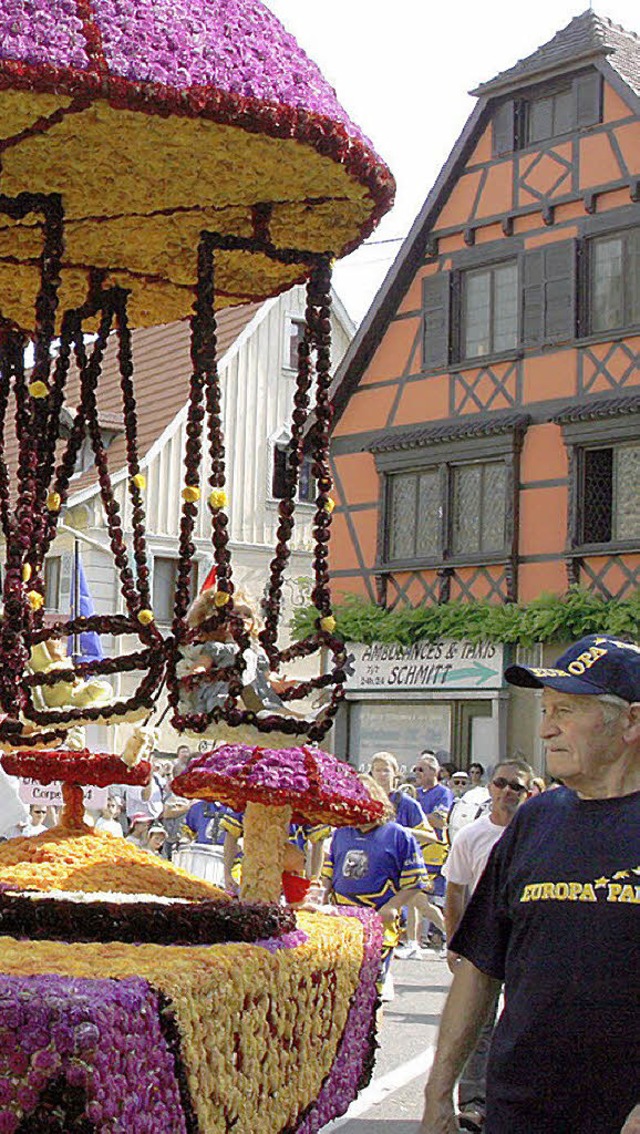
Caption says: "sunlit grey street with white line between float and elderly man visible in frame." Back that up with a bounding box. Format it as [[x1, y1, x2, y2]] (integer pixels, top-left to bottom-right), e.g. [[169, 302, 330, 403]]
[[322, 953, 452, 1134]]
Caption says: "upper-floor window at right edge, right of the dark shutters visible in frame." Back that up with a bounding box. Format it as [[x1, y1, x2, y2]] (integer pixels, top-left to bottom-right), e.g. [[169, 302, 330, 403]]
[[589, 228, 640, 335]]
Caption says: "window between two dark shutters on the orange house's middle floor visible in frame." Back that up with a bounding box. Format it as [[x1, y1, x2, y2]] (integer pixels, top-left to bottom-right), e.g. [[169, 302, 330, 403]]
[[462, 261, 517, 358]]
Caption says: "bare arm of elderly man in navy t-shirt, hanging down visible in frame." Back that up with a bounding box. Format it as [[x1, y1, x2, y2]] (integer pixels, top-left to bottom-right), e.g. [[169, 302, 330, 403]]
[[419, 959, 500, 1134]]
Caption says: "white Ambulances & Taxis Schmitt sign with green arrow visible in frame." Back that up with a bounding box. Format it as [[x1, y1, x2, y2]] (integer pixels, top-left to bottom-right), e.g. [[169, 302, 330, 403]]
[[346, 638, 504, 693]]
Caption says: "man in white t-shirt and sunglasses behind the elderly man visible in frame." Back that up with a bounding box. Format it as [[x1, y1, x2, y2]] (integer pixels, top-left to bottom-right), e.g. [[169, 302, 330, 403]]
[[443, 760, 533, 1131]]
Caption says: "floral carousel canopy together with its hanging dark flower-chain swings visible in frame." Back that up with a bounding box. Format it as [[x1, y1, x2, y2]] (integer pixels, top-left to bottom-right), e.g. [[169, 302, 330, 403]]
[[0, 0, 394, 745]]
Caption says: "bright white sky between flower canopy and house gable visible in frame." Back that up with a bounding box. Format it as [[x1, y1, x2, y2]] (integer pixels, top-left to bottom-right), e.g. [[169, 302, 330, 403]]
[[264, 0, 640, 321]]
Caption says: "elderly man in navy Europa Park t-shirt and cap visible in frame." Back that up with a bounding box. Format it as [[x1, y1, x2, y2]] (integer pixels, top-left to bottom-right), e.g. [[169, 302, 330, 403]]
[[420, 635, 640, 1134]]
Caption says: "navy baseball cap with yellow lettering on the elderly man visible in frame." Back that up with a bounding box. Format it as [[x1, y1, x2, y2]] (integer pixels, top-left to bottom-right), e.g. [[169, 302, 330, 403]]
[[505, 634, 640, 704]]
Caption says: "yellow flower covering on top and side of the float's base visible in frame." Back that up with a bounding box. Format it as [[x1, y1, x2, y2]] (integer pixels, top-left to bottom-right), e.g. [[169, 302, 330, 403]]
[[0, 912, 363, 1134]]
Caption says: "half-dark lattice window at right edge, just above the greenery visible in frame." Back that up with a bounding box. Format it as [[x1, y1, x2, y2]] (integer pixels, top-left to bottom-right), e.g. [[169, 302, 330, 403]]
[[579, 443, 640, 544]]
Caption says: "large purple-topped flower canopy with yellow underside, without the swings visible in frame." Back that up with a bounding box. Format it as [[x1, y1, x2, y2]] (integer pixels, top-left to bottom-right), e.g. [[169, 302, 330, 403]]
[[0, 0, 394, 330]]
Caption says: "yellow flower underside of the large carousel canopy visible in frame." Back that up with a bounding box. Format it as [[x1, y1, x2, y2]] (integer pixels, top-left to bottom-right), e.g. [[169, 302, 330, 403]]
[[0, 91, 372, 328]]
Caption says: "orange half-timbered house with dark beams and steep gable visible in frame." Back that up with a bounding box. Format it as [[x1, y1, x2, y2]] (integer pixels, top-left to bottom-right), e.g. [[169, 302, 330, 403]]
[[331, 10, 640, 763]]
